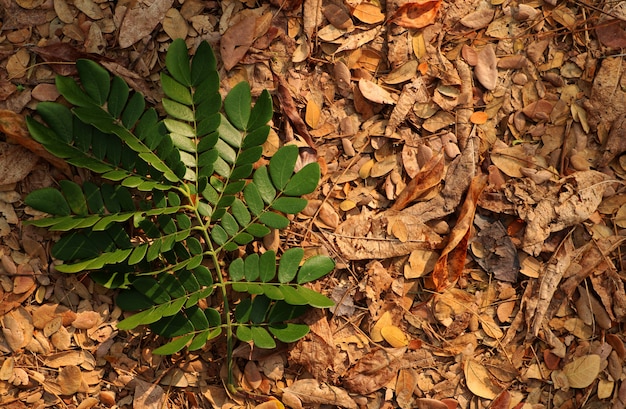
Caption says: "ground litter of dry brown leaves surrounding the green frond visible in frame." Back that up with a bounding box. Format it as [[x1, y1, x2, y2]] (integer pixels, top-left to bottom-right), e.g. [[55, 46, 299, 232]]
[[0, 0, 626, 409]]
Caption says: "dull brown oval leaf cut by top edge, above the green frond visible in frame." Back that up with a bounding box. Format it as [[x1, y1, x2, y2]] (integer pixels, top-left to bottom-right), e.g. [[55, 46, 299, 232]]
[[118, 0, 173, 48]]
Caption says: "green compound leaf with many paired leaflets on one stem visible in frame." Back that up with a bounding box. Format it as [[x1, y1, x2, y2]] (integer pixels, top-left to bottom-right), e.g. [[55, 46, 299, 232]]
[[26, 40, 334, 384]]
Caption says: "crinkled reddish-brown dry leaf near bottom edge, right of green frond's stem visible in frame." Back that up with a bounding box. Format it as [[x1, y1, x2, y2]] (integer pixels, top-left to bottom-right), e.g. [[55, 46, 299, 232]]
[[344, 348, 406, 395]]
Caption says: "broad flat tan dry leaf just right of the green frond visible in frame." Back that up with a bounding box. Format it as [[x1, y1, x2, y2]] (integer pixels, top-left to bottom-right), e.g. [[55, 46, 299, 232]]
[[325, 210, 442, 260]]
